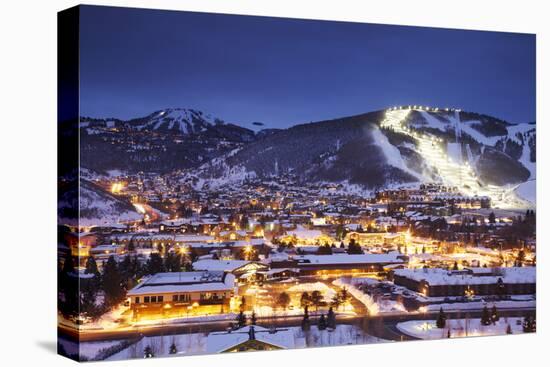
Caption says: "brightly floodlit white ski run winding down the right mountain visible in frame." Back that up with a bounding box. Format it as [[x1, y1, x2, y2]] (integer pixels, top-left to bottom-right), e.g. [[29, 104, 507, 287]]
[[381, 106, 531, 209]]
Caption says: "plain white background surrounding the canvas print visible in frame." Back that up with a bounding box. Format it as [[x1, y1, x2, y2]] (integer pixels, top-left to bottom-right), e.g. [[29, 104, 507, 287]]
[[0, 0, 550, 367]]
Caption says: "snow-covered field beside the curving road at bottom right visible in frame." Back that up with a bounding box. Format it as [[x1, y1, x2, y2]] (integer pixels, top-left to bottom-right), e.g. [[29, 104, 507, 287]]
[[397, 317, 523, 339]]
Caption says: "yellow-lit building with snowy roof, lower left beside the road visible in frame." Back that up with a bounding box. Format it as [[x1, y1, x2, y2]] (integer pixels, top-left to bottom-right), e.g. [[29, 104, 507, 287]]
[[128, 271, 235, 319]]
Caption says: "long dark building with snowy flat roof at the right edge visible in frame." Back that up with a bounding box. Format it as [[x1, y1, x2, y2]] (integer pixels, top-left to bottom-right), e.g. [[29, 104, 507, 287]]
[[393, 267, 536, 297]]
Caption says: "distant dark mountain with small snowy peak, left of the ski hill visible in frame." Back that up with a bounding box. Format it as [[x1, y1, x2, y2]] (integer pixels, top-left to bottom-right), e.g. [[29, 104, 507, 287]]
[[80, 108, 256, 173]]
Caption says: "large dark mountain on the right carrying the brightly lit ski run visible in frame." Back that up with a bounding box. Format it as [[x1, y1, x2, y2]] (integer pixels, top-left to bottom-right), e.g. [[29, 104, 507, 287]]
[[184, 106, 536, 207]]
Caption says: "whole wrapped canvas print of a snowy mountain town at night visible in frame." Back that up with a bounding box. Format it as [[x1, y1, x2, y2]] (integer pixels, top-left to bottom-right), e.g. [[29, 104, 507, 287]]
[[57, 6, 536, 361]]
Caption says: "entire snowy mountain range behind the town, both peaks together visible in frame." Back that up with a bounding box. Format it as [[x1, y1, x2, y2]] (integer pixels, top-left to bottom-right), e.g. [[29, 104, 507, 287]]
[[80, 106, 536, 208]]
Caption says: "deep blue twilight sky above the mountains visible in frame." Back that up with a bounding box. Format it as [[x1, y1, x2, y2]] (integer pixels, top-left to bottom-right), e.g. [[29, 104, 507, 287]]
[[80, 6, 535, 127]]
